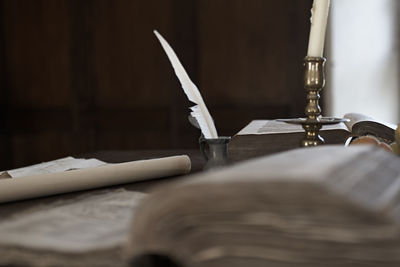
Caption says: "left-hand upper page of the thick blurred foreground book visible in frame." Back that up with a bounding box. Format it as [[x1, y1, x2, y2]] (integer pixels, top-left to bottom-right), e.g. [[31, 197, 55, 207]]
[[182, 145, 374, 183]]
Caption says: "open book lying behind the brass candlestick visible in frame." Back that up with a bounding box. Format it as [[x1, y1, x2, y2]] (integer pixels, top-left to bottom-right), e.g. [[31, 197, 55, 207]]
[[228, 113, 396, 161]]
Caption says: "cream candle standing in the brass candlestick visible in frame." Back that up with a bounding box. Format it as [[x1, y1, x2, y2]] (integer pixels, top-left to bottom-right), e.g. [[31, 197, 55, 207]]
[[307, 0, 330, 57]]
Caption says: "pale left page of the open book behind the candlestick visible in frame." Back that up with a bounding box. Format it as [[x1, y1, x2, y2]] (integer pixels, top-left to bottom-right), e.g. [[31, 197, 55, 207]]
[[238, 120, 347, 135]]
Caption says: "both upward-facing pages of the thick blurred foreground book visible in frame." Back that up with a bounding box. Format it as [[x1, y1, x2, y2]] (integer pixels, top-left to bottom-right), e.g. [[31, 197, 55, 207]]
[[182, 145, 400, 222]]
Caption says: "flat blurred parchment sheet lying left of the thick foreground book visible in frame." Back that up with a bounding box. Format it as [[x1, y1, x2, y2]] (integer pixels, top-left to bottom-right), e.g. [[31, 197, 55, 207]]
[[0, 189, 146, 253]]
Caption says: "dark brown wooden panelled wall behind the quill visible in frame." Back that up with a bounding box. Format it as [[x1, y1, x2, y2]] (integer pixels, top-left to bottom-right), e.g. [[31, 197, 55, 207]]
[[0, 0, 311, 169]]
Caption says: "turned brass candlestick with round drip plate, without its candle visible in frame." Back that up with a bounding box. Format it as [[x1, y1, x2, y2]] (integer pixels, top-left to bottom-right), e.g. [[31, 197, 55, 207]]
[[280, 57, 347, 147]]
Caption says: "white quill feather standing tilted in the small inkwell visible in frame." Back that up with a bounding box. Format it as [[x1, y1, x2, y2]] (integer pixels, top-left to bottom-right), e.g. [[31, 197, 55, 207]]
[[154, 31, 218, 139]]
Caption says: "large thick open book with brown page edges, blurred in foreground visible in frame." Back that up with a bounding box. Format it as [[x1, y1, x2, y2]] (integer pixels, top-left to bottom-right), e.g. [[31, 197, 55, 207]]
[[127, 146, 400, 267]]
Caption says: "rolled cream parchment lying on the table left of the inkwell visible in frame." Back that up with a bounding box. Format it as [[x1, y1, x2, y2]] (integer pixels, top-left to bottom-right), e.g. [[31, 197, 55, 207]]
[[0, 155, 191, 203]]
